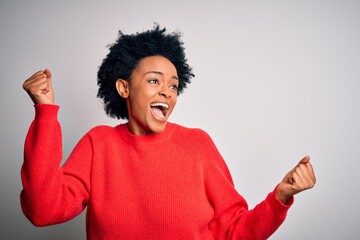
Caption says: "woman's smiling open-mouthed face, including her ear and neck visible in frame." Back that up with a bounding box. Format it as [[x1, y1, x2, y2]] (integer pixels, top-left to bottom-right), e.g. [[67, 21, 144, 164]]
[[116, 56, 179, 135]]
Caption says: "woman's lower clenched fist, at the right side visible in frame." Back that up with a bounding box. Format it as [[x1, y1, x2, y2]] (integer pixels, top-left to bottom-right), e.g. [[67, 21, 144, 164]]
[[277, 156, 316, 203]]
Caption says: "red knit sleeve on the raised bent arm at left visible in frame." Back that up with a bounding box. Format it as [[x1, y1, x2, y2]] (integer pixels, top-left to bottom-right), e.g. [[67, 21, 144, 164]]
[[20, 105, 91, 226]]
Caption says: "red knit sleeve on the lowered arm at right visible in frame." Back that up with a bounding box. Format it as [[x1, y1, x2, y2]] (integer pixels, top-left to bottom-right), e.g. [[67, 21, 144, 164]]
[[195, 129, 293, 240]]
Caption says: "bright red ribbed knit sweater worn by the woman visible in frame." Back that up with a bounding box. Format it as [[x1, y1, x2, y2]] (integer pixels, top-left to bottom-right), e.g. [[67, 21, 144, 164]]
[[21, 105, 293, 240]]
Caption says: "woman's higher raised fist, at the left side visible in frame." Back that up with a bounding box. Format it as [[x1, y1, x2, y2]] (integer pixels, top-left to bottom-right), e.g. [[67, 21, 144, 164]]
[[23, 69, 54, 104]]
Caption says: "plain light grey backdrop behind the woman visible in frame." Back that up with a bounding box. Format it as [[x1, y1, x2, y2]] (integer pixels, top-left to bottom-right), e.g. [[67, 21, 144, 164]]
[[0, 0, 360, 240]]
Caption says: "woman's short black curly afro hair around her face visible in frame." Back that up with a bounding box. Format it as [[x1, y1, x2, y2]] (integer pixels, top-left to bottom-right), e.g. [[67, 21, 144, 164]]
[[97, 24, 195, 119]]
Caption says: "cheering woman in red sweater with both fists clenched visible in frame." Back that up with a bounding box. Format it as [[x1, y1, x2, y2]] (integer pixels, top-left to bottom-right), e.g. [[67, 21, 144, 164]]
[[21, 23, 315, 240]]
